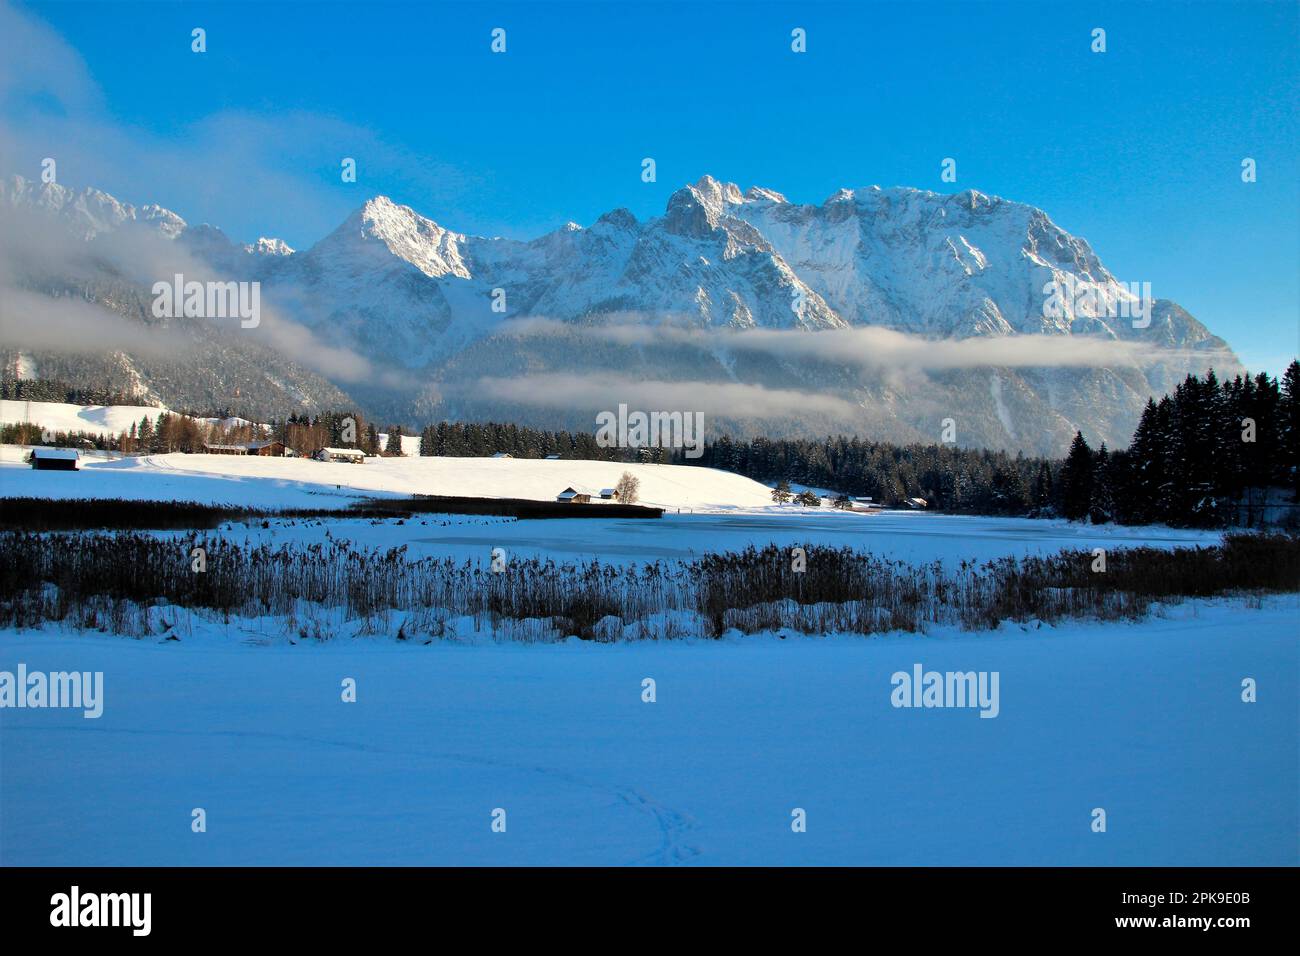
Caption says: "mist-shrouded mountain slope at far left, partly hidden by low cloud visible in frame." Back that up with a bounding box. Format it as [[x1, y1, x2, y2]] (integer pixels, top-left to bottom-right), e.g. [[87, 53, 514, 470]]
[[0, 177, 354, 419]]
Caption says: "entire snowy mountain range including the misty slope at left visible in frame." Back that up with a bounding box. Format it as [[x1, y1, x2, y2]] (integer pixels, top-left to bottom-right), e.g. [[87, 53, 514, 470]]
[[0, 176, 1242, 454]]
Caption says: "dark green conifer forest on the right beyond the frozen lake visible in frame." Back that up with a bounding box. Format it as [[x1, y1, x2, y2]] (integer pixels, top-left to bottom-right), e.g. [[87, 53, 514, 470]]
[[675, 362, 1300, 527]]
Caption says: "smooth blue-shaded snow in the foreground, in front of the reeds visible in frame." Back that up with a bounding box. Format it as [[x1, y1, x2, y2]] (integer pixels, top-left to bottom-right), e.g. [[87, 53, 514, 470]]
[[0, 596, 1300, 865]]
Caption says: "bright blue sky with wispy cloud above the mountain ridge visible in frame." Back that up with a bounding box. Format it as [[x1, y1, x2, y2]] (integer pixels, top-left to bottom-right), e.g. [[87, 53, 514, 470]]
[[0, 0, 1300, 372]]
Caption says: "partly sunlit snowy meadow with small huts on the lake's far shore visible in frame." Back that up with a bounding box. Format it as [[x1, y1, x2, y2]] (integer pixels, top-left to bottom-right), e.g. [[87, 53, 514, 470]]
[[0, 446, 772, 511]]
